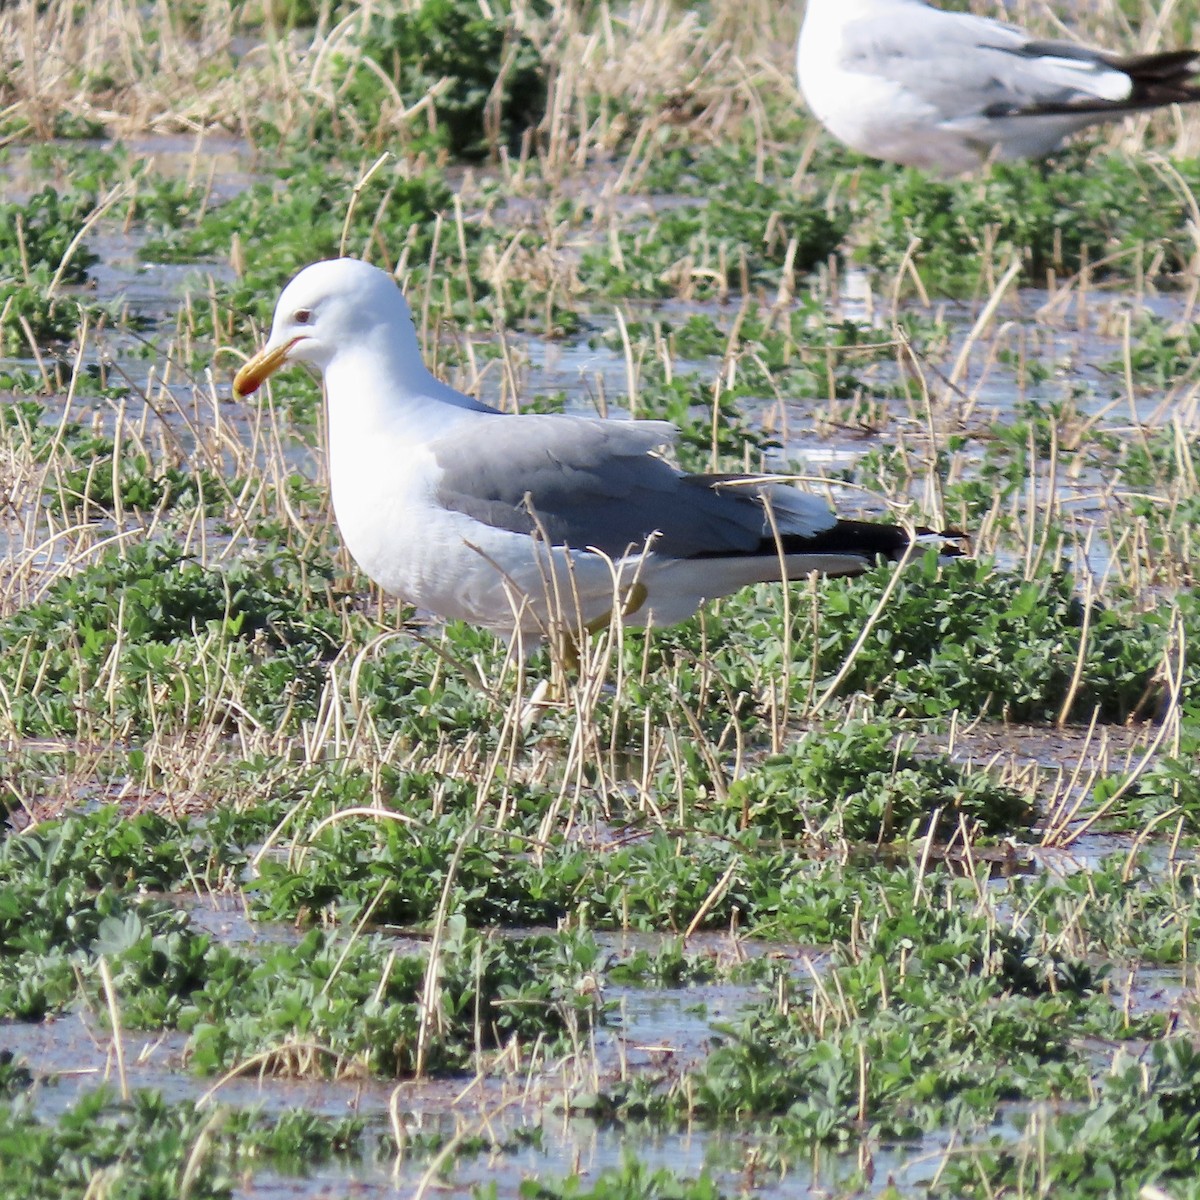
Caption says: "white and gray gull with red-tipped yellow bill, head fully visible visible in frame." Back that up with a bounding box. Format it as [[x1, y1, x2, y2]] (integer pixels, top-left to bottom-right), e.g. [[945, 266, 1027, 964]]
[[234, 258, 954, 650]]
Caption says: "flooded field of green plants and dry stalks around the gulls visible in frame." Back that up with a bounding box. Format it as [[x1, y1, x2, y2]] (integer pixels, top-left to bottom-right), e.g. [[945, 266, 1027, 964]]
[[0, 0, 1200, 1200]]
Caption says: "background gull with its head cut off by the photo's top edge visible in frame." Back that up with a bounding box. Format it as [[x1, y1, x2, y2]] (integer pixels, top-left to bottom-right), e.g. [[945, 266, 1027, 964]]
[[796, 0, 1200, 175]]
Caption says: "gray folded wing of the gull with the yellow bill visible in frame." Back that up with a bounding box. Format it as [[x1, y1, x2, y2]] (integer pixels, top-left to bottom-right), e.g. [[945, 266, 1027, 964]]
[[431, 414, 836, 558]]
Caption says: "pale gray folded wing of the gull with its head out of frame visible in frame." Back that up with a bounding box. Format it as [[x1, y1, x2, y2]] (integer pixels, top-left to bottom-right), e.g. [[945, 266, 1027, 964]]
[[841, 4, 1200, 122]]
